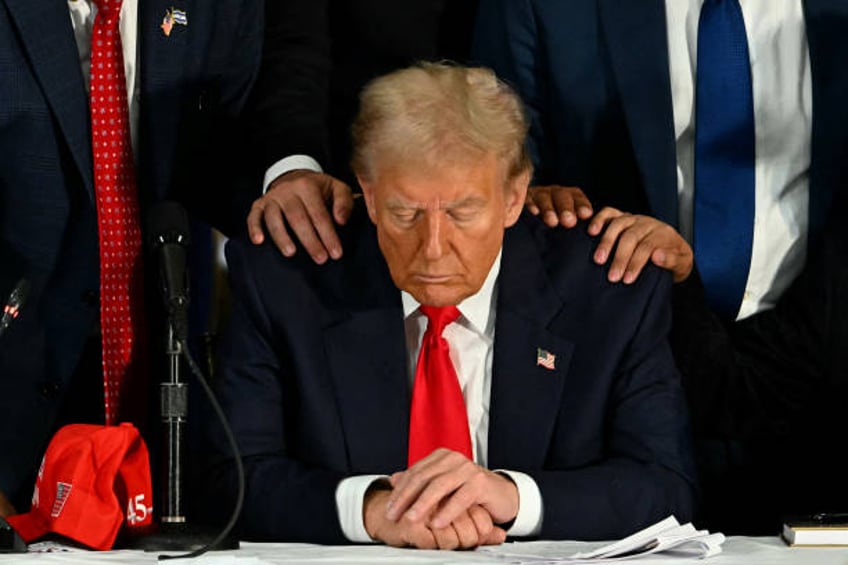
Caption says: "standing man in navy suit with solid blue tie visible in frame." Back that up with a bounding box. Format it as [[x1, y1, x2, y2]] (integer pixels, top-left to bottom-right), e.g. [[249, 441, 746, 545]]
[[475, 0, 848, 533]]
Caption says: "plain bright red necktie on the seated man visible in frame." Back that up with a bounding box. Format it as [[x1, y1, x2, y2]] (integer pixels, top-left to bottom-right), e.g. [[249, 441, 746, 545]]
[[409, 306, 472, 466]]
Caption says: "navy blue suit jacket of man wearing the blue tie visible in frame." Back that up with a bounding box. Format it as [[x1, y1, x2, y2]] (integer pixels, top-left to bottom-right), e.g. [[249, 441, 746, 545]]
[[474, 0, 848, 240]]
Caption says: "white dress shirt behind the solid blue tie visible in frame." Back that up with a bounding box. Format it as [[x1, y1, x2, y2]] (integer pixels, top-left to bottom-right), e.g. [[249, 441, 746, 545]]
[[665, 0, 812, 319]]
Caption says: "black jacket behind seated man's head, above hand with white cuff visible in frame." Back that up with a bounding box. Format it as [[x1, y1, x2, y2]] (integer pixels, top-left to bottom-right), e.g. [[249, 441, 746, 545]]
[[252, 0, 477, 183]]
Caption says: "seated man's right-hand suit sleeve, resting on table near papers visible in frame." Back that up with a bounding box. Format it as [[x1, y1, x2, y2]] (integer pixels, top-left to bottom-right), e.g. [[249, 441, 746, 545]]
[[528, 272, 695, 539]]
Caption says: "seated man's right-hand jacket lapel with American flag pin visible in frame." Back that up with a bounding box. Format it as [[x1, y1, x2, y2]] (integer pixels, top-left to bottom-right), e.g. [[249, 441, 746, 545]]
[[488, 222, 574, 469]]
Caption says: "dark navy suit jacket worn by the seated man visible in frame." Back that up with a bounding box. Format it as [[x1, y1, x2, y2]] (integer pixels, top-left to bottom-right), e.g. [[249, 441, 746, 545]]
[[205, 209, 693, 543]]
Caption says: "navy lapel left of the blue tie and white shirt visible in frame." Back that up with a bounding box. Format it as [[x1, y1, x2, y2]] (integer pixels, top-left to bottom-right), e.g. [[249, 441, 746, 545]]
[[600, 0, 677, 226]]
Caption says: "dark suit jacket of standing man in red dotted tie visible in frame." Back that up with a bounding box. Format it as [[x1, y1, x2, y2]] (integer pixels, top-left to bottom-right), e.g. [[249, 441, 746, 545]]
[[0, 0, 262, 506]]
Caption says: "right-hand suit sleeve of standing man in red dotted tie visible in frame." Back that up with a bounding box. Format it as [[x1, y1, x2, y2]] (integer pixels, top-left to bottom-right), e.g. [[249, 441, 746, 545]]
[[169, 0, 264, 237]]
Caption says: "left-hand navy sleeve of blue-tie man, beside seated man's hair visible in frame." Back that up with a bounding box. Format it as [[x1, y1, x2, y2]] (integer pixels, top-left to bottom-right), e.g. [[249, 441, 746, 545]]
[[471, 0, 553, 184]]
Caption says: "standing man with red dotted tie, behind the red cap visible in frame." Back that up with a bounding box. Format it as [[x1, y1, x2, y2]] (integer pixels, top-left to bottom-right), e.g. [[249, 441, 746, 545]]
[[0, 0, 262, 515]]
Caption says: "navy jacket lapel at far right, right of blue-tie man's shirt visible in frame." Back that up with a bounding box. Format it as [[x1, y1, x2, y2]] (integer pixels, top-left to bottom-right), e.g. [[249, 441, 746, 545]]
[[804, 0, 848, 240]]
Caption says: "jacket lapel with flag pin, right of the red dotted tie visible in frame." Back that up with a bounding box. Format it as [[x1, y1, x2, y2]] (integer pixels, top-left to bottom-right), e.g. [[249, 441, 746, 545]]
[[138, 0, 191, 198]]
